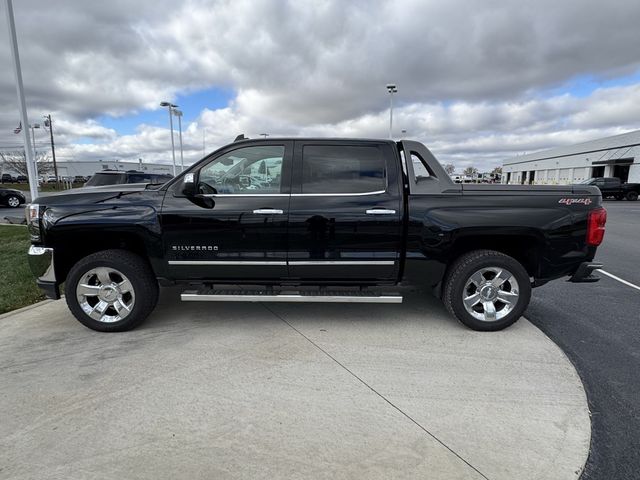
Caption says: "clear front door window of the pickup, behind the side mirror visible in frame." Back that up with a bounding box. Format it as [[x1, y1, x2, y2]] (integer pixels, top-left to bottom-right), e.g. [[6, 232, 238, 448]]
[[198, 145, 284, 195]]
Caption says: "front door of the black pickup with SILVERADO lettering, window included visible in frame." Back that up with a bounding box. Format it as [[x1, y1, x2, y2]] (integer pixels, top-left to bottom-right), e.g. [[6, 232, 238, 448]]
[[161, 141, 293, 282]]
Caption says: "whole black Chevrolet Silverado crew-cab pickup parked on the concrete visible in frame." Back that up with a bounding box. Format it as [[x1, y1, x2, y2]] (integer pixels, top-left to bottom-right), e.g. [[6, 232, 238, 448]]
[[27, 139, 606, 331]]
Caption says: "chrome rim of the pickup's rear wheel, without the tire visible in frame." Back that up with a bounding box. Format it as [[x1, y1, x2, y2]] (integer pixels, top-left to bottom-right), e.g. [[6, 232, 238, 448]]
[[462, 267, 520, 322]]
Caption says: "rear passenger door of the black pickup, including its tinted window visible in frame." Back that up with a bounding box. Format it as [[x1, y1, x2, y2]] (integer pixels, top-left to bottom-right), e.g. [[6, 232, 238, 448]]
[[288, 141, 402, 283]]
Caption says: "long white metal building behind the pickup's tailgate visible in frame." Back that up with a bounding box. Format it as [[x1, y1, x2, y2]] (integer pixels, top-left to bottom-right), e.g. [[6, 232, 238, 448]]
[[502, 130, 640, 185]]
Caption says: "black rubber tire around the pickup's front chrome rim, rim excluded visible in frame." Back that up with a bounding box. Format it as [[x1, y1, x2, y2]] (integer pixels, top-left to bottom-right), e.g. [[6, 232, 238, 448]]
[[64, 250, 158, 332]]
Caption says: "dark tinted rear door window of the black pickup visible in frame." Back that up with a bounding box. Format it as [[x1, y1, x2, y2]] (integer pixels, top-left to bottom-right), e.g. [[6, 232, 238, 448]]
[[302, 145, 386, 193]]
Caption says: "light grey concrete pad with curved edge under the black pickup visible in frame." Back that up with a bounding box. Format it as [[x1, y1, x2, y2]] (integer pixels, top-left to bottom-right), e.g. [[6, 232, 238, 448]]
[[0, 290, 590, 480]]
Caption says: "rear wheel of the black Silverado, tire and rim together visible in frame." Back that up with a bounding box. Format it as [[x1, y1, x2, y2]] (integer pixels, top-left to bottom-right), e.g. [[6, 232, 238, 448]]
[[442, 250, 531, 331]]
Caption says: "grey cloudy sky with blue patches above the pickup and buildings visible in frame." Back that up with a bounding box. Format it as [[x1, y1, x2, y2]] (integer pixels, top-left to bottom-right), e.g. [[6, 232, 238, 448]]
[[0, 0, 640, 170]]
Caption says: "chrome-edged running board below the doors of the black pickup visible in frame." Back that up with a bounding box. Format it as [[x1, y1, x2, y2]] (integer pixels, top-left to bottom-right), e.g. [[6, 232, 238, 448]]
[[180, 290, 402, 303]]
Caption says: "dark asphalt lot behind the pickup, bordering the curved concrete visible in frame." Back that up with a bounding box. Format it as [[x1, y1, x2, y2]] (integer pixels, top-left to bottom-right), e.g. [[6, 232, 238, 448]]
[[525, 200, 640, 480]]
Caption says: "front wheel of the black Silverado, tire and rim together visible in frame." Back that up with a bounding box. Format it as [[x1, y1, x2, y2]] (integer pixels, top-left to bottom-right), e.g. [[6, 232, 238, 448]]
[[65, 250, 158, 332]]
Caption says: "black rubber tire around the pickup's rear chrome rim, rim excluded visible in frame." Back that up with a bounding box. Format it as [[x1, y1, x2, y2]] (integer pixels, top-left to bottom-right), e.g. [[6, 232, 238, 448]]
[[442, 250, 531, 332]]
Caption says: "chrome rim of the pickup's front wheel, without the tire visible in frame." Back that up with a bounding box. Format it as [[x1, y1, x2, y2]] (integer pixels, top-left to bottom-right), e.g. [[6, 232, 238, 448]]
[[76, 267, 136, 323]]
